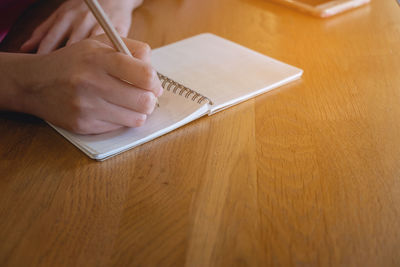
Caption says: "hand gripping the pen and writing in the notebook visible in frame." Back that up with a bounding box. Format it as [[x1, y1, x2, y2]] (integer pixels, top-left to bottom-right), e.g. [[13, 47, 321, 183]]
[[14, 35, 163, 134]]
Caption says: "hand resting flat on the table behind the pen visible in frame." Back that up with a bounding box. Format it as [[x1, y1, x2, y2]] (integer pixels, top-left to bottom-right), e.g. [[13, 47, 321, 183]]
[[21, 0, 143, 54]]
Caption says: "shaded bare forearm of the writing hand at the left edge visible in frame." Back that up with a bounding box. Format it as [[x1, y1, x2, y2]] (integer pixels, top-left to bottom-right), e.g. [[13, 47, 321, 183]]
[[0, 53, 34, 112]]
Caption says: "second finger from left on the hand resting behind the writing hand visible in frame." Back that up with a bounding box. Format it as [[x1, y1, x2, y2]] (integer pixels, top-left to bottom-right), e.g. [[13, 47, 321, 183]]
[[37, 15, 71, 54]]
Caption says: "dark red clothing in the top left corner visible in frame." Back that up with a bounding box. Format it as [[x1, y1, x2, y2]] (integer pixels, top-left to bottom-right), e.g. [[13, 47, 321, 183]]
[[0, 0, 35, 42]]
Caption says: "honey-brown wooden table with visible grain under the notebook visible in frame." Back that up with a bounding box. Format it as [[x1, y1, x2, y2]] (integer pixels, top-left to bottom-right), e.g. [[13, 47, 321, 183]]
[[0, 0, 400, 266]]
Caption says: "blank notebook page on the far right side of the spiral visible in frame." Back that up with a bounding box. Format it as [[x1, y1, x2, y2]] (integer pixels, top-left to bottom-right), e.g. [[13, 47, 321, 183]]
[[152, 34, 302, 113]]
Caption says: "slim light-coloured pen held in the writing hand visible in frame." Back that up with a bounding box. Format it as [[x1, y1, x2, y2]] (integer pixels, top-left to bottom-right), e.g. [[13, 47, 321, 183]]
[[85, 0, 160, 107]]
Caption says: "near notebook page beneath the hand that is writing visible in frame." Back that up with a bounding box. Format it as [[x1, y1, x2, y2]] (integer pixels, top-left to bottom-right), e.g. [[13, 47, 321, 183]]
[[52, 90, 208, 160]]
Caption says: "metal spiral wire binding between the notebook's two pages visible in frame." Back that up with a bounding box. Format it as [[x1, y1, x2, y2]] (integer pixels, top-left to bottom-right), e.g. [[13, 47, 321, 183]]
[[157, 73, 213, 105]]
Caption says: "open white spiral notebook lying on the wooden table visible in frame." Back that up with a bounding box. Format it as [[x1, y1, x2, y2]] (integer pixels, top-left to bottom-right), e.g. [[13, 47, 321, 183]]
[[52, 33, 303, 160]]
